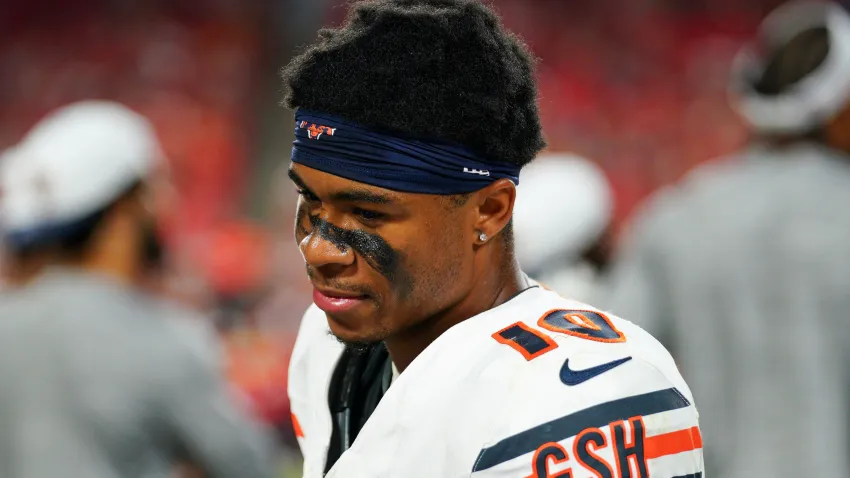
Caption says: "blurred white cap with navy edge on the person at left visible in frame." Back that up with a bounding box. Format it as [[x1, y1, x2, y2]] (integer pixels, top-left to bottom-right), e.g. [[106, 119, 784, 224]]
[[0, 101, 162, 245]]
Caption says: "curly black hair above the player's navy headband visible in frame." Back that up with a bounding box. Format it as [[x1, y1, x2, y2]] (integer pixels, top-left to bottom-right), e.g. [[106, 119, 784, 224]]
[[282, 0, 545, 166]]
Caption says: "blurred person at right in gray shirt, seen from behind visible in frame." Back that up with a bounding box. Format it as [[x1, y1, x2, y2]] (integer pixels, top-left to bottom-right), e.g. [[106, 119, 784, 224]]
[[606, 3, 850, 478]]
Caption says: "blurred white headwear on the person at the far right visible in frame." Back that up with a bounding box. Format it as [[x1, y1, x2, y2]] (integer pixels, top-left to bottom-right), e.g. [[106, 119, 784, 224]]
[[730, 0, 850, 134]]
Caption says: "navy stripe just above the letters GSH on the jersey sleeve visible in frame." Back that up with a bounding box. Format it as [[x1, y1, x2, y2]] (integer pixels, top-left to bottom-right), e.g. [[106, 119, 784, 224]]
[[472, 388, 691, 473]]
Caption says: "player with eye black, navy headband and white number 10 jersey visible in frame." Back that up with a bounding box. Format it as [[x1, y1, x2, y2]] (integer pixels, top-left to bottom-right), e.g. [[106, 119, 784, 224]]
[[283, 0, 702, 478]]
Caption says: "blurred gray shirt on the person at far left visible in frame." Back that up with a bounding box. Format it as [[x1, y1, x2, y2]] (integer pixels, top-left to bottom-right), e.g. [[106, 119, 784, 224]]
[[0, 270, 271, 478]]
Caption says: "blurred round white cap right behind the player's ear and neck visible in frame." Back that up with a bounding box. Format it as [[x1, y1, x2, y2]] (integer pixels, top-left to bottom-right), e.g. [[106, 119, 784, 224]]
[[513, 154, 613, 272]]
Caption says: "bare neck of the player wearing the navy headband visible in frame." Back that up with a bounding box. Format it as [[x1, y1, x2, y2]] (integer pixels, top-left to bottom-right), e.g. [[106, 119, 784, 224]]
[[384, 244, 529, 372]]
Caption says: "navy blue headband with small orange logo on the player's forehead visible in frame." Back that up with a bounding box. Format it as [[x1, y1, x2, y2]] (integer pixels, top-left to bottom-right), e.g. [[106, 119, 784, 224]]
[[292, 109, 520, 195]]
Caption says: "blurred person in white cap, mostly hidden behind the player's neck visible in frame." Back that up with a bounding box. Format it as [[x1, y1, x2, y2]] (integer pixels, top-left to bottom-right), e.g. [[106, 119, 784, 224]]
[[506, 153, 613, 304]]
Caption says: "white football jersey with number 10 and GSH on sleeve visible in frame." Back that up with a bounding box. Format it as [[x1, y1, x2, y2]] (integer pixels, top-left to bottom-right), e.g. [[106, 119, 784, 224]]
[[289, 287, 703, 478]]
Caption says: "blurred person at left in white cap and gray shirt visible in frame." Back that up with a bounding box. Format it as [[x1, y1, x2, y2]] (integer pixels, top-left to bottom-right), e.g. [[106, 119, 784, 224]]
[[0, 101, 271, 478]]
